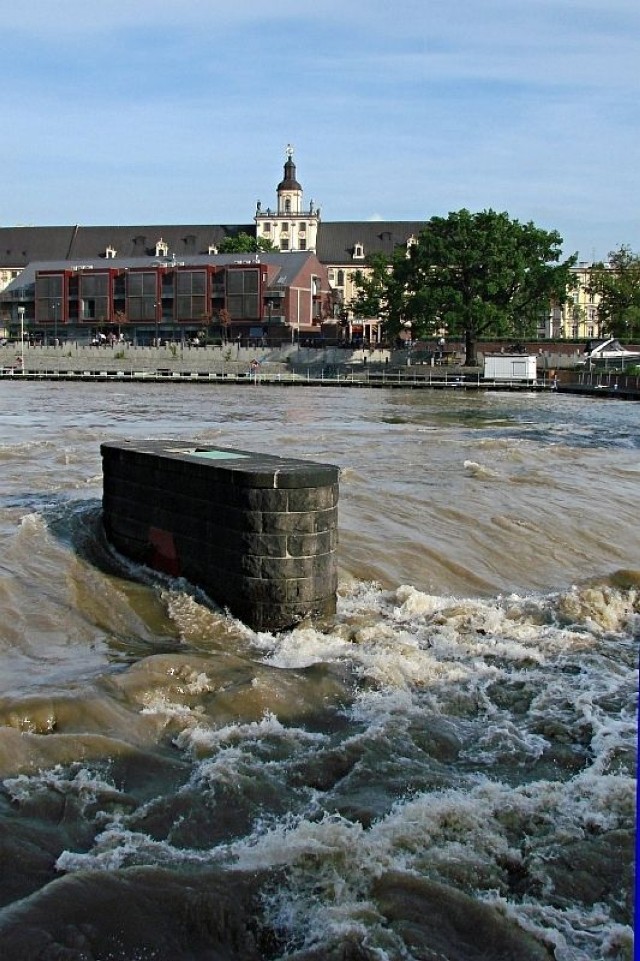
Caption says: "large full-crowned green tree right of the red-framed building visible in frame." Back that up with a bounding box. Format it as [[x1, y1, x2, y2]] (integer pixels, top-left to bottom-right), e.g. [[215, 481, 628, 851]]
[[350, 210, 576, 365]]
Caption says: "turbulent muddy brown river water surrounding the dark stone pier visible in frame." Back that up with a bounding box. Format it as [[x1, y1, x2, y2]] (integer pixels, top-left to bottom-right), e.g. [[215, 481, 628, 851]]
[[0, 382, 640, 961]]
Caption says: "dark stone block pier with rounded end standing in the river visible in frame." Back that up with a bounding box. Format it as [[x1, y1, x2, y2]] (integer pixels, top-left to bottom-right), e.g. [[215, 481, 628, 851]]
[[100, 440, 339, 631]]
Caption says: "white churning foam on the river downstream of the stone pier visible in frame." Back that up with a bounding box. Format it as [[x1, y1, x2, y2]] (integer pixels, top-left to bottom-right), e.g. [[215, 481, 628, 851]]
[[13, 568, 638, 961]]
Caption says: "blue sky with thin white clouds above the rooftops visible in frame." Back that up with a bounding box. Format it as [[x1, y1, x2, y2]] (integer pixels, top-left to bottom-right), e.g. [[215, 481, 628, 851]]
[[0, 0, 640, 261]]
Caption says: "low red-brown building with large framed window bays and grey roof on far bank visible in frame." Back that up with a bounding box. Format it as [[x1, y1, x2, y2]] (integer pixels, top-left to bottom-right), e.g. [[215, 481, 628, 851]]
[[0, 252, 334, 345]]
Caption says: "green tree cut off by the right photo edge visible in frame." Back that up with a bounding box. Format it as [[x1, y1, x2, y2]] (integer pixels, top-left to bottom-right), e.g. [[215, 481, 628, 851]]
[[587, 244, 640, 340]]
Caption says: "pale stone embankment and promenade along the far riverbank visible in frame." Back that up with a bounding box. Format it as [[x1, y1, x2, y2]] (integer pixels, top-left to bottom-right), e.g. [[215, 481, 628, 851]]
[[0, 343, 640, 400]]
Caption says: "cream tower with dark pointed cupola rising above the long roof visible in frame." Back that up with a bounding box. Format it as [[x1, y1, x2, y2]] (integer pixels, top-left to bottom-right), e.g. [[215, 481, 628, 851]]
[[254, 144, 320, 252]]
